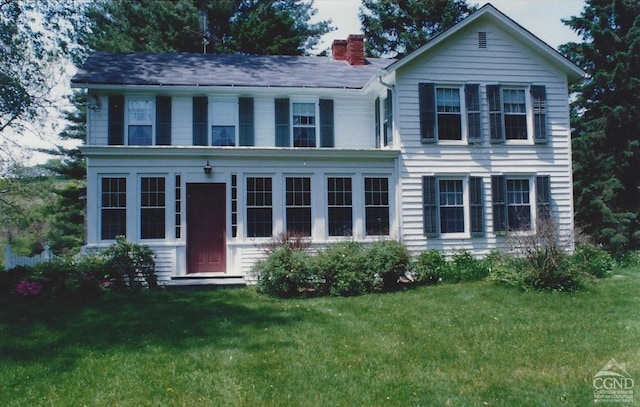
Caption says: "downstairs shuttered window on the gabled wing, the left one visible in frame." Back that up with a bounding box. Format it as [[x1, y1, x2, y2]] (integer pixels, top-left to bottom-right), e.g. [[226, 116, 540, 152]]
[[422, 176, 484, 237]]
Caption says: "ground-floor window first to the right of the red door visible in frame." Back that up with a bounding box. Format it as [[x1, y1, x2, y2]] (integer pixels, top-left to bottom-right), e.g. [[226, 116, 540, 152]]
[[247, 177, 273, 237]]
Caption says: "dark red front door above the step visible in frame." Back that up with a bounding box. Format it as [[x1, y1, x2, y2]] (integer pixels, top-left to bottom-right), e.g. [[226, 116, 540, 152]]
[[187, 183, 227, 273]]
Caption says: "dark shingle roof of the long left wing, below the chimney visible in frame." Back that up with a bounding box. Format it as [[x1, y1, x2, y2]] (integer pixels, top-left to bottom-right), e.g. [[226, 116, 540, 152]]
[[71, 52, 394, 89]]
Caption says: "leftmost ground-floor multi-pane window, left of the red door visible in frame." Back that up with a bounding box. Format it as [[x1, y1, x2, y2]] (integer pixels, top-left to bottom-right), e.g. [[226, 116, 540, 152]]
[[100, 177, 127, 240]]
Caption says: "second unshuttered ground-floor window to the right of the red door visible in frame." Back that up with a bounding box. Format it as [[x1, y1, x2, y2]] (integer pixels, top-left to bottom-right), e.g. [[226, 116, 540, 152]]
[[286, 177, 311, 236]]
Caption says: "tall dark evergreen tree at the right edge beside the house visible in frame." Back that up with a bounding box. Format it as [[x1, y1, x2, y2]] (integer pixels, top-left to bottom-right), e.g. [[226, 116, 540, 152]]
[[561, 0, 640, 253]]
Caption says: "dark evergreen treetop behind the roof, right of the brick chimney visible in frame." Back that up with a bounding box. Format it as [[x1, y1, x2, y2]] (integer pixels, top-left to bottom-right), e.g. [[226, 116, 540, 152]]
[[359, 0, 476, 58]]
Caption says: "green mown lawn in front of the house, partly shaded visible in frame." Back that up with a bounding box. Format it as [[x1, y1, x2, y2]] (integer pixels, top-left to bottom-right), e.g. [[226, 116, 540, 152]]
[[0, 269, 640, 406]]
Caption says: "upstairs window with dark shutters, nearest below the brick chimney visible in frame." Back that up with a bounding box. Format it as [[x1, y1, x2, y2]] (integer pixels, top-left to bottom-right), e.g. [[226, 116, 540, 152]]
[[274, 98, 335, 147]]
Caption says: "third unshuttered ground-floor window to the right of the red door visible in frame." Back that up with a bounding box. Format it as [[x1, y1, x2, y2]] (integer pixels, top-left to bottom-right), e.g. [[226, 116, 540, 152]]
[[327, 177, 353, 236]]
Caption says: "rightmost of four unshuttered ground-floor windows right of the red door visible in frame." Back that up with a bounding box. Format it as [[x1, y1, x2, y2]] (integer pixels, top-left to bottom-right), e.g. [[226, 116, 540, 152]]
[[364, 178, 389, 236]]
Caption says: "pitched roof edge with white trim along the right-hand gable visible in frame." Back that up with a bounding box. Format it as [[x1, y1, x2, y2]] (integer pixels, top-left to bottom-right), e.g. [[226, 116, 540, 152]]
[[385, 3, 586, 82]]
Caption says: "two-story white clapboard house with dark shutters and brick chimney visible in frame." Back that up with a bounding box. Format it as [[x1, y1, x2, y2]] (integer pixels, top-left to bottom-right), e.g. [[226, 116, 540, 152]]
[[72, 5, 584, 284]]
